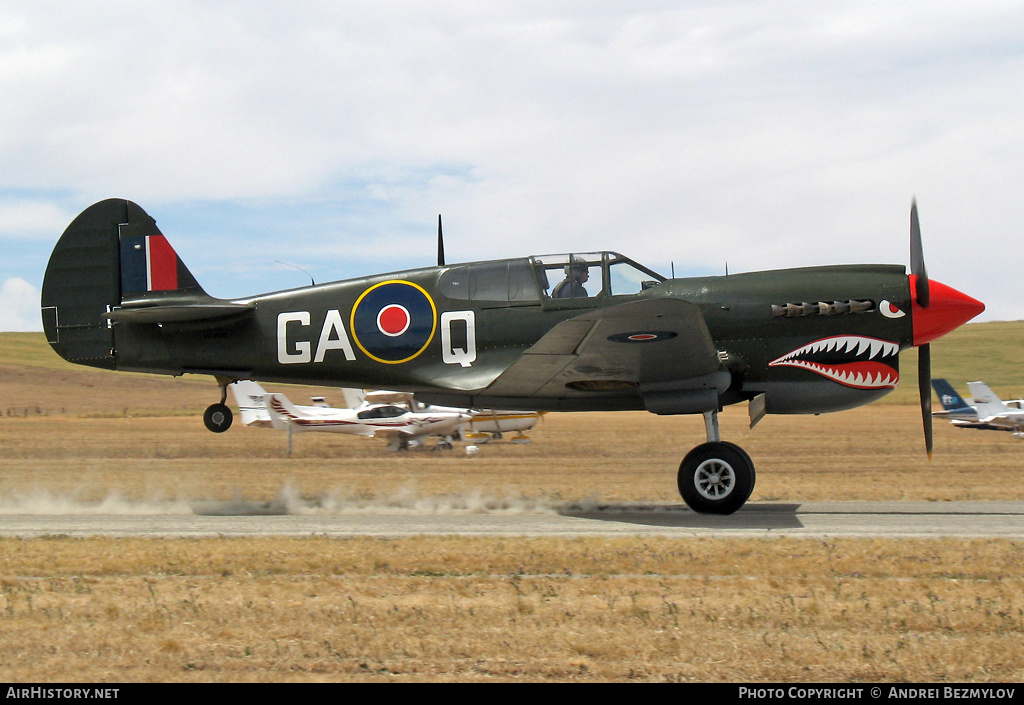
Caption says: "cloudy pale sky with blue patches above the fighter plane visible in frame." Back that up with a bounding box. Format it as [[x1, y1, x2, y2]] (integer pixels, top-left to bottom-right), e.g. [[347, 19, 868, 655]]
[[0, 0, 1024, 330]]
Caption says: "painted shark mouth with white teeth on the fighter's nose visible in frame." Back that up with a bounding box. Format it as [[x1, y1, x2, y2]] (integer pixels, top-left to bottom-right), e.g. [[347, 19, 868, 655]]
[[768, 335, 899, 389]]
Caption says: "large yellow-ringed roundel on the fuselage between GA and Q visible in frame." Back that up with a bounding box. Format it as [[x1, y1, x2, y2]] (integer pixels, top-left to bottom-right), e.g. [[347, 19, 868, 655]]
[[351, 280, 437, 365]]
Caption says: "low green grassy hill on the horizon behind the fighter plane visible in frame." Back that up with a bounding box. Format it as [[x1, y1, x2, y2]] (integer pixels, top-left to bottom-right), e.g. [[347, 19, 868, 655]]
[[0, 321, 1024, 404]]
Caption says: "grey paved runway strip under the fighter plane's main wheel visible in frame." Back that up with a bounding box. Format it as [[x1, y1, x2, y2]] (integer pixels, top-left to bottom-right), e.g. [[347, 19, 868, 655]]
[[6, 502, 1024, 539]]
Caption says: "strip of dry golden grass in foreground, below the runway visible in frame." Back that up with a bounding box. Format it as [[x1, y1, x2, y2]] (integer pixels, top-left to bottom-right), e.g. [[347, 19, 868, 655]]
[[6, 537, 1024, 682]]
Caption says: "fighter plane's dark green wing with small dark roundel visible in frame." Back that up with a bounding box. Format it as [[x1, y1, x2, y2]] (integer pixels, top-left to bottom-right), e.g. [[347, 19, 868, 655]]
[[484, 298, 721, 398]]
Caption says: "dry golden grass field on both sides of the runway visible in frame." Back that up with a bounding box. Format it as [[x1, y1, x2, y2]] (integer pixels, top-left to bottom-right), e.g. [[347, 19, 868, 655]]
[[0, 324, 1024, 682]]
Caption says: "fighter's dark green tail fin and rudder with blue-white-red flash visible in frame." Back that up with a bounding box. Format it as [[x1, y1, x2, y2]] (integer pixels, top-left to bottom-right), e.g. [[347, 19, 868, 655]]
[[41, 199, 209, 369]]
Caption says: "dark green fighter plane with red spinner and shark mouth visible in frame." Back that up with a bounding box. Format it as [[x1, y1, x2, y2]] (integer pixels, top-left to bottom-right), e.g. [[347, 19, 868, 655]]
[[41, 199, 984, 513]]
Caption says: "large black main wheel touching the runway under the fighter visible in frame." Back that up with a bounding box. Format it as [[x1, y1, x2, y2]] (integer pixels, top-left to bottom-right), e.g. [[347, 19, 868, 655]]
[[678, 441, 756, 514]]
